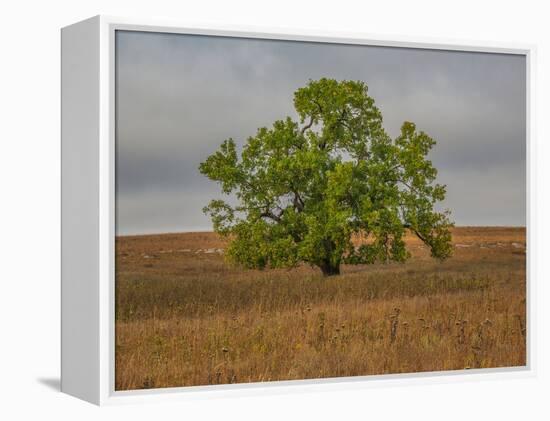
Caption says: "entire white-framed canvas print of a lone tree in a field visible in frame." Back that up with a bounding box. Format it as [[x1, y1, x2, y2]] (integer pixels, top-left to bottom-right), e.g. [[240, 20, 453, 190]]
[[62, 17, 533, 404]]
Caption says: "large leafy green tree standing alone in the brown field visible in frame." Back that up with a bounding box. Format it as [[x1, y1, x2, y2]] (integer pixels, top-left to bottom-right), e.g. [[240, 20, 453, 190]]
[[199, 78, 453, 276]]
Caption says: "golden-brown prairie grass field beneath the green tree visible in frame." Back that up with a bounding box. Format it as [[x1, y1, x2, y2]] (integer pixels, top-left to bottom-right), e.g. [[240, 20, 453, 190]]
[[115, 227, 527, 390]]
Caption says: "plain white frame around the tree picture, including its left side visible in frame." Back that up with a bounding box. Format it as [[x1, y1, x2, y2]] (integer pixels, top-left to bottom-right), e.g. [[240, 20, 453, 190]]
[[61, 16, 536, 405]]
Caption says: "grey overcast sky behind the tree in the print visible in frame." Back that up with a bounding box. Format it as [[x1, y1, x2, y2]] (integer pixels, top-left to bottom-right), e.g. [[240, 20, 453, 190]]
[[116, 31, 526, 235]]
